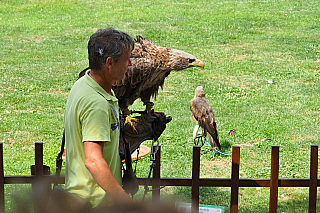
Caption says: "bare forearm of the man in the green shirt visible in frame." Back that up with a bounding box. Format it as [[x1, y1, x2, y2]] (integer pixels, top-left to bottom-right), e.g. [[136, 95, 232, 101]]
[[84, 141, 132, 203]]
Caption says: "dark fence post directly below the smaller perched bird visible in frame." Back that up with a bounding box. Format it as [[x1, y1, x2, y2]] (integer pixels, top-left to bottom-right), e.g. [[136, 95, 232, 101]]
[[191, 145, 201, 213]]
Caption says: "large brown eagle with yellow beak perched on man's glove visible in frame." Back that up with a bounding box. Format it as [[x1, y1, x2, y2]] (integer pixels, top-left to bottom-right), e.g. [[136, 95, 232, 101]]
[[79, 36, 204, 115]]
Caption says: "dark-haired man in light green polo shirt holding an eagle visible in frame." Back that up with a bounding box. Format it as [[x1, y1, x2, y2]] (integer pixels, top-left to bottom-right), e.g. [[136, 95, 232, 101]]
[[64, 28, 134, 208]]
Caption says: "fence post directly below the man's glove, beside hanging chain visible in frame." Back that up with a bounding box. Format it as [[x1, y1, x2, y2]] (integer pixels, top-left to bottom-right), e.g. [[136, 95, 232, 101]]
[[152, 145, 161, 203]]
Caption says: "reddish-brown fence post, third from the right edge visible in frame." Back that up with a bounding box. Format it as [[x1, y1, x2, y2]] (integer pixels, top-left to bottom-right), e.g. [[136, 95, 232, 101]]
[[230, 146, 240, 213]]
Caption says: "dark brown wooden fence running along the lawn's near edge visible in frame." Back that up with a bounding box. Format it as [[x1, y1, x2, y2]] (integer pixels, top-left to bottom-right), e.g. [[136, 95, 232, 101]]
[[0, 142, 320, 213]]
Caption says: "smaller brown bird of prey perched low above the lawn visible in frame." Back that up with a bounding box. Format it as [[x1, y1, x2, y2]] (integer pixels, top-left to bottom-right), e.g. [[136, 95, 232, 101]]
[[190, 86, 221, 150]]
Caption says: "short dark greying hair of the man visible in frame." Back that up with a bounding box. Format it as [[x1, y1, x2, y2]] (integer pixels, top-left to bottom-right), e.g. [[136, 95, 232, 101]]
[[88, 27, 134, 71]]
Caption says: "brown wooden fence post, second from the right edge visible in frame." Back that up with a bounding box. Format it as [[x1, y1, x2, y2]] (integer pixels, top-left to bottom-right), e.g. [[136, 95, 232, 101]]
[[269, 146, 279, 213]]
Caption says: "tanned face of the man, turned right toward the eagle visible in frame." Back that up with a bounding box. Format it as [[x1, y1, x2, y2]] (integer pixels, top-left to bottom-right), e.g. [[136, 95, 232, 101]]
[[113, 48, 132, 81]]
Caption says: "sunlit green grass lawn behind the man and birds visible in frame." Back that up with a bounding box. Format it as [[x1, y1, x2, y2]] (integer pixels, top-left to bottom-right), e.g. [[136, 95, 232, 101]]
[[0, 0, 320, 212]]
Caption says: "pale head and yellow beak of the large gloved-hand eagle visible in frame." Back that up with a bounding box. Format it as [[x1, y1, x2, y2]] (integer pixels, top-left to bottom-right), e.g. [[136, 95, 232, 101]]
[[168, 49, 204, 71]]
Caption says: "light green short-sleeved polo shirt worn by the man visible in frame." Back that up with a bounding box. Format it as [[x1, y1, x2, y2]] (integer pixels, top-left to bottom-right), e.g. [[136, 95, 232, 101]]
[[64, 72, 121, 207]]
